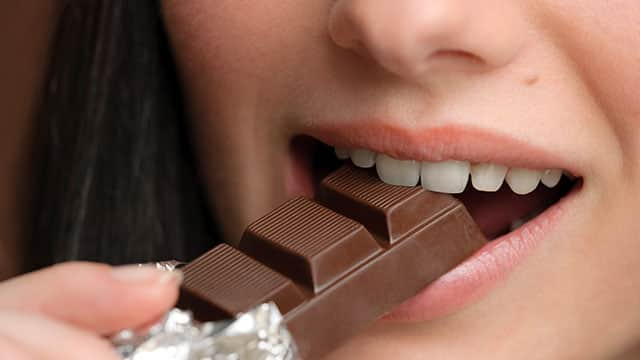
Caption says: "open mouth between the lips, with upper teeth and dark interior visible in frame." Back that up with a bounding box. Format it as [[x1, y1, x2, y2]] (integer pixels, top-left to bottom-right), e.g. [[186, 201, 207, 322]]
[[290, 135, 582, 240]]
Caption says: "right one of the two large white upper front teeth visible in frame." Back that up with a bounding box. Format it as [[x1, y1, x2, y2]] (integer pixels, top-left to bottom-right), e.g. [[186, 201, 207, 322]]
[[420, 160, 470, 194]]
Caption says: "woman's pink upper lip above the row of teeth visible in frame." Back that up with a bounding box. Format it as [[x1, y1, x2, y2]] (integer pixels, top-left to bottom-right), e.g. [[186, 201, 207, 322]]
[[307, 121, 580, 176]]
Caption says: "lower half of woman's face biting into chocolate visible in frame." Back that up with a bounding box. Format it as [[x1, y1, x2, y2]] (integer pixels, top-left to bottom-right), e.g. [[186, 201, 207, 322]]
[[163, 0, 640, 359]]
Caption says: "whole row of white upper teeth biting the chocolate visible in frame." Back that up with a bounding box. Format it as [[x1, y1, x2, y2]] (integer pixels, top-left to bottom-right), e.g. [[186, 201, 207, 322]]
[[335, 148, 562, 195]]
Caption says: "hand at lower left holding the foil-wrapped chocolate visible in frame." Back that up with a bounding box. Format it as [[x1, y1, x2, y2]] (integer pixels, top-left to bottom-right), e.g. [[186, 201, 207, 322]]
[[0, 262, 180, 360]]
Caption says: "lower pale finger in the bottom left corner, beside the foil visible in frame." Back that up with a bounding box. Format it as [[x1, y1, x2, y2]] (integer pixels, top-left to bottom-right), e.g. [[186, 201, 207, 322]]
[[0, 312, 118, 360]]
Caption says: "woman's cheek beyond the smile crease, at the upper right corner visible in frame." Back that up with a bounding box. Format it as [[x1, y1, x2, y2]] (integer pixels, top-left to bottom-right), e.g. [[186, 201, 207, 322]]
[[541, 0, 640, 174]]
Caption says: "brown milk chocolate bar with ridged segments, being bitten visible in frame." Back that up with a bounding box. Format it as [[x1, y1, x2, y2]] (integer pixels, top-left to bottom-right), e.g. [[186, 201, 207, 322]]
[[179, 165, 486, 360]]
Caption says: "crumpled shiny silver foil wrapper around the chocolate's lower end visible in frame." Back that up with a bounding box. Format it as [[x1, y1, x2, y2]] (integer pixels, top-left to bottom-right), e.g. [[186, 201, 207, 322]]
[[111, 262, 298, 360]]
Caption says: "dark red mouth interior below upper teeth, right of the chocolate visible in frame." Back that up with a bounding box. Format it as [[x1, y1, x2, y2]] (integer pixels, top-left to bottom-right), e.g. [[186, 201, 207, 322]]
[[457, 184, 566, 239]]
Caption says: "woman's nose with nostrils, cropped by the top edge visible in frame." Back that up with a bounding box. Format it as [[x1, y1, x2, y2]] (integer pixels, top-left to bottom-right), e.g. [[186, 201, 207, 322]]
[[329, 0, 525, 80]]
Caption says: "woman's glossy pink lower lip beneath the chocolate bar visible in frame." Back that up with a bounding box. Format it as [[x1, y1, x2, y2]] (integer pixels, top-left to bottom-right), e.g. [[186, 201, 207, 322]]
[[383, 186, 581, 321]]
